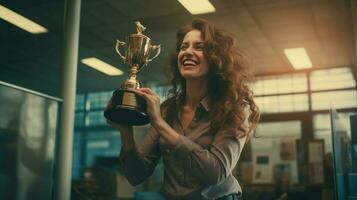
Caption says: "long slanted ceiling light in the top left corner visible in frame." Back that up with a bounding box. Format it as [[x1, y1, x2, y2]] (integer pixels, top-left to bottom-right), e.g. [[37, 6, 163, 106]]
[[0, 5, 48, 34]]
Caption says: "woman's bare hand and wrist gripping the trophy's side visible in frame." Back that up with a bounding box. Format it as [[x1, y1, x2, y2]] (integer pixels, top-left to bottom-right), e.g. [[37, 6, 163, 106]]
[[135, 88, 163, 126]]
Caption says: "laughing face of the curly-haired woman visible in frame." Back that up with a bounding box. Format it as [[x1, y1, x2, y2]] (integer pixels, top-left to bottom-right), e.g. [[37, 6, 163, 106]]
[[177, 30, 208, 78]]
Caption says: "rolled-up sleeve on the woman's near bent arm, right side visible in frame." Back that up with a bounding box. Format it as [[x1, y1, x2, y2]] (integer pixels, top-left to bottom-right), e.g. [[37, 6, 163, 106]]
[[173, 129, 241, 185]]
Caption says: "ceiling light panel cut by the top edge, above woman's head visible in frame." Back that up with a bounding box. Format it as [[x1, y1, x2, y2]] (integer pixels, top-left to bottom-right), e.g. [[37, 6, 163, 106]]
[[178, 0, 216, 15]]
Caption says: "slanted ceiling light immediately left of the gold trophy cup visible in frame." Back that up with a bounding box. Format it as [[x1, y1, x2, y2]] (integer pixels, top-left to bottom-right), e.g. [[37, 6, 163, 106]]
[[81, 57, 123, 76]]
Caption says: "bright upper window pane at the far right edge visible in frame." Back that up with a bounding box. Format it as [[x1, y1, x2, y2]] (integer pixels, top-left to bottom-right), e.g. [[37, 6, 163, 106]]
[[310, 68, 356, 91]]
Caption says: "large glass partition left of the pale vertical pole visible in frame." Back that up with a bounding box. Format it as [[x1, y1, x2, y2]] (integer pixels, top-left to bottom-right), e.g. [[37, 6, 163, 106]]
[[0, 82, 59, 200]]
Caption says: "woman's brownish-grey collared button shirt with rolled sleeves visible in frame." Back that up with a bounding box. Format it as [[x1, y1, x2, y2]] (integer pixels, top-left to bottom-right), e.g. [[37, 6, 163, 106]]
[[120, 98, 247, 200]]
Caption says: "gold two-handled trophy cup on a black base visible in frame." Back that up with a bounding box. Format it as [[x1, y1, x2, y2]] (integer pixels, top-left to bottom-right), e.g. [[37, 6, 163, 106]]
[[104, 21, 161, 125]]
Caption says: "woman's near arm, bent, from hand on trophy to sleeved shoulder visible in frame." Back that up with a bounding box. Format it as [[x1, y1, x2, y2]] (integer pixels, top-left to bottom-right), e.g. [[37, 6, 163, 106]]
[[137, 88, 248, 185]]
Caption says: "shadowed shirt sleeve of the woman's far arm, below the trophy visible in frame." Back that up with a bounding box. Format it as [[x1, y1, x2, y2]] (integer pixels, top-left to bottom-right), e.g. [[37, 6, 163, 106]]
[[119, 127, 161, 185]]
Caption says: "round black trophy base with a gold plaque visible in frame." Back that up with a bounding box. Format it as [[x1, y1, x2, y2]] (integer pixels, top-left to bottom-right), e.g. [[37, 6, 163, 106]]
[[104, 89, 150, 126]]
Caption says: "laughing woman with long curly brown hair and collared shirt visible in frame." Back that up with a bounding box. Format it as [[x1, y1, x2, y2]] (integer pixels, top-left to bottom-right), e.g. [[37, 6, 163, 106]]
[[108, 19, 259, 200]]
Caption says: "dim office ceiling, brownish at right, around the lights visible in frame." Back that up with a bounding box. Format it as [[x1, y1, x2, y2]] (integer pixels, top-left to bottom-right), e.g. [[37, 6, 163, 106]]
[[0, 0, 357, 97]]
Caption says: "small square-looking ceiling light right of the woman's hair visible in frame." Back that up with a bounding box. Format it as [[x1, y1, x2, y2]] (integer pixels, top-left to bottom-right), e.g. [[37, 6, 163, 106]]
[[284, 48, 312, 69]]
